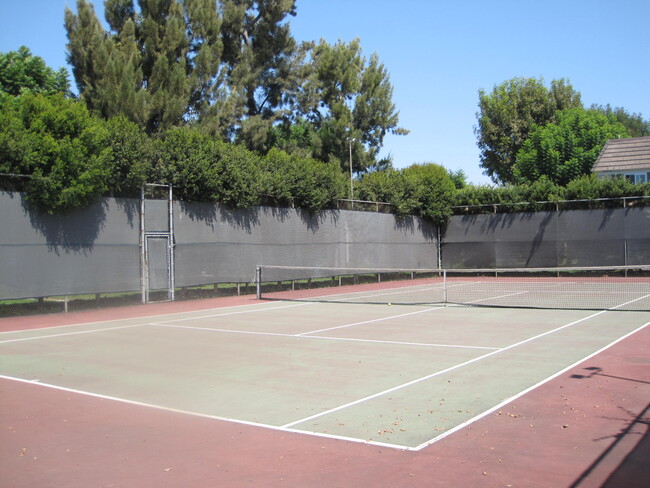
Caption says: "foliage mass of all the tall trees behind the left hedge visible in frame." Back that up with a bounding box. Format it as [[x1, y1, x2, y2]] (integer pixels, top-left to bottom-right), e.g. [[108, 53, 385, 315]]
[[65, 0, 406, 172]]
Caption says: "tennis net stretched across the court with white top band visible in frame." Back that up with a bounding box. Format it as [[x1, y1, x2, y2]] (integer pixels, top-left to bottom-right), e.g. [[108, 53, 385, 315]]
[[256, 265, 650, 311]]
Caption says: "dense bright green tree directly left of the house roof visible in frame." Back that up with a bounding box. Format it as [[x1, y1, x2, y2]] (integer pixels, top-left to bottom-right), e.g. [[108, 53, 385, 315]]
[[513, 108, 627, 186]]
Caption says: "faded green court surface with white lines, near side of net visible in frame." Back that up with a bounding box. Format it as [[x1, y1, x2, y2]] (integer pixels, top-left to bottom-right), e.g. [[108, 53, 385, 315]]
[[0, 301, 650, 450]]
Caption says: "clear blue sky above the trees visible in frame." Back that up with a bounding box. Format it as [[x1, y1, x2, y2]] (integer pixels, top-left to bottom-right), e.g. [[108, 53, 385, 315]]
[[0, 0, 650, 184]]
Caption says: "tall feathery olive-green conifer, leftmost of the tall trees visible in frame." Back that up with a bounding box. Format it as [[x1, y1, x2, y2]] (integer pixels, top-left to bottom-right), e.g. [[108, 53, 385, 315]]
[[65, 0, 221, 133]]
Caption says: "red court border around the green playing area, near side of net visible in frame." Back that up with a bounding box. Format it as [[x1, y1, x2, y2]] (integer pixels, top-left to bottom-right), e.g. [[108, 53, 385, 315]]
[[0, 297, 650, 488]]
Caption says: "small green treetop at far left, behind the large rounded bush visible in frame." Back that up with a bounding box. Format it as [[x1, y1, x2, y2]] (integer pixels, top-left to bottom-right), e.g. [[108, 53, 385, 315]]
[[0, 46, 70, 95]]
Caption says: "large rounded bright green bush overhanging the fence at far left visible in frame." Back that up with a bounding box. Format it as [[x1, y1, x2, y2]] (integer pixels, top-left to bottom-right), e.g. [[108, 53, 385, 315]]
[[0, 92, 111, 212]]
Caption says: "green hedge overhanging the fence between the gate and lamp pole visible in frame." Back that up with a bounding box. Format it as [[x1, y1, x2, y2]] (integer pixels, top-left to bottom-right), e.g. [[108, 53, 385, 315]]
[[153, 128, 347, 210]]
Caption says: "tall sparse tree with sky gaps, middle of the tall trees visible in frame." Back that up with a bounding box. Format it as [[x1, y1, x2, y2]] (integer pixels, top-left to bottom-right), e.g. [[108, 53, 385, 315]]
[[210, 0, 308, 148]]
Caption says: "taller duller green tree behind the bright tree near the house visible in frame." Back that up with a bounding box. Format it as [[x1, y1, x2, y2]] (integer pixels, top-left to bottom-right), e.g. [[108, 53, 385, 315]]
[[474, 78, 582, 183]]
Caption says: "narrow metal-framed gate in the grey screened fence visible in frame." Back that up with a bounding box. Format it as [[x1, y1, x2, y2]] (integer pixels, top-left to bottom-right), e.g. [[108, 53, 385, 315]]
[[140, 185, 174, 303]]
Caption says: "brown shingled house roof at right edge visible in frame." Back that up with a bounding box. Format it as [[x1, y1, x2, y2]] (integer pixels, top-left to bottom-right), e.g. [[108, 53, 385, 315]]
[[593, 136, 650, 173]]
